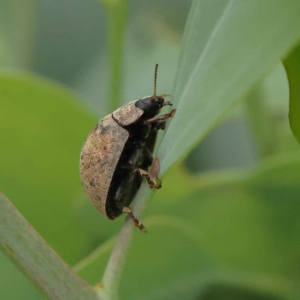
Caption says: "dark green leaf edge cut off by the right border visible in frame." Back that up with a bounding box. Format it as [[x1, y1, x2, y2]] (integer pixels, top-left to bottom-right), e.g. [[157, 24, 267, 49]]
[[284, 44, 300, 143]]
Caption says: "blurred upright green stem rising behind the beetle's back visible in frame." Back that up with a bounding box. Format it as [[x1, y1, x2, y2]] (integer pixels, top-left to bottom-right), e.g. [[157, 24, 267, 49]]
[[107, 0, 128, 111]]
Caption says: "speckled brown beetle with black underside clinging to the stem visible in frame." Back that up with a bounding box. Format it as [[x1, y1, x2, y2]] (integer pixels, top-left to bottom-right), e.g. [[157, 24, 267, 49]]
[[80, 64, 176, 231]]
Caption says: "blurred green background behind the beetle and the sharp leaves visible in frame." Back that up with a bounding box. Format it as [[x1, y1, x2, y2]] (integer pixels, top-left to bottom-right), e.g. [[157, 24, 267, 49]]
[[0, 0, 300, 300]]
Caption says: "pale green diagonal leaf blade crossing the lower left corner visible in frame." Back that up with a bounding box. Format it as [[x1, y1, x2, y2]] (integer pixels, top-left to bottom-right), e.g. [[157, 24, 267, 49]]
[[0, 194, 98, 300]]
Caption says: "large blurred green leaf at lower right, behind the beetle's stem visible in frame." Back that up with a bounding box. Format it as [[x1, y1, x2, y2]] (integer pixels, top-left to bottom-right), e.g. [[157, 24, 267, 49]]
[[78, 153, 300, 299]]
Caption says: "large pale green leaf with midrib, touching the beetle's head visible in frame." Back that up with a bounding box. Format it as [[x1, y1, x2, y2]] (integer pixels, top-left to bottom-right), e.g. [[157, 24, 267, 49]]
[[159, 0, 300, 173]]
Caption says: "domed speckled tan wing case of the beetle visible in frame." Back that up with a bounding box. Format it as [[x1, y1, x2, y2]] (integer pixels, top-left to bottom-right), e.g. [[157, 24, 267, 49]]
[[80, 115, 129, 215]]
